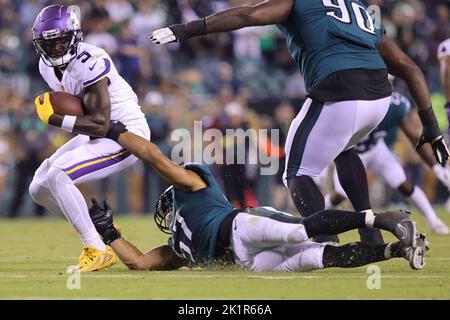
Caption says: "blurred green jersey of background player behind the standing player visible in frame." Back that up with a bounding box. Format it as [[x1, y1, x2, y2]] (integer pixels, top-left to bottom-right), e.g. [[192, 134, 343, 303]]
[[355, 92, 411, 153]]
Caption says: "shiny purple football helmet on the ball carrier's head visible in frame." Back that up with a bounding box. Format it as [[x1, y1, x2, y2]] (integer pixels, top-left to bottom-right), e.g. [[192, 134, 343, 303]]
[[32, 5, 83, 67]]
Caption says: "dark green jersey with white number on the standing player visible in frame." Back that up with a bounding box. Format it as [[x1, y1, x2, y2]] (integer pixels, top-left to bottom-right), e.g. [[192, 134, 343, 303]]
[[279, 0, 386, 91]]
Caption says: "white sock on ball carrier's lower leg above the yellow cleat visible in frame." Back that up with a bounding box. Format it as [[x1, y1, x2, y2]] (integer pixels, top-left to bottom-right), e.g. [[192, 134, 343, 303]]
[[48, 167, 106, 251]]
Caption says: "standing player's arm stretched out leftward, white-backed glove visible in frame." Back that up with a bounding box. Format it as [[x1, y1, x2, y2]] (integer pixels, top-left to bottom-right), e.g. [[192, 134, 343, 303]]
[[150, 0, 294, 44]]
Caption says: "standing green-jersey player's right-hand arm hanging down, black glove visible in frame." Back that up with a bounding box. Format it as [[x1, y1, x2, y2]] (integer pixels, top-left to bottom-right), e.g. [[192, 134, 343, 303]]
[[379, 36, 449, 165]]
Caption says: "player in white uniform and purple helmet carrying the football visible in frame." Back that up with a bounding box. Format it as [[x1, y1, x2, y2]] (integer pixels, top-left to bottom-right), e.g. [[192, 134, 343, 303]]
[[29, 5, 150, 272]]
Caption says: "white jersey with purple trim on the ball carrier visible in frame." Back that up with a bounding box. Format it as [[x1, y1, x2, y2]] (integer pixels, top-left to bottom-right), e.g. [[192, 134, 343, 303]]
[[39, 42, 146, 125]]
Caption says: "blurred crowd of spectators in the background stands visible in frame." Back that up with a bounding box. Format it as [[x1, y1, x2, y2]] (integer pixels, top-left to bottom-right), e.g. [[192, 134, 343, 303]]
[[0, 0, 450, 216]]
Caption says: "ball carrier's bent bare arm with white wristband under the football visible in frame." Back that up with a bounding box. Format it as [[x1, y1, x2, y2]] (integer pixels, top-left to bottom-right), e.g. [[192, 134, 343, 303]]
[[44, 78, 111, 137]]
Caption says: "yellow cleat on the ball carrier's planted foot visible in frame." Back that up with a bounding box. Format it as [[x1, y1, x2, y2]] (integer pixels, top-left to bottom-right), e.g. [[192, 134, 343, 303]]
[[78, 246, 117, 272]]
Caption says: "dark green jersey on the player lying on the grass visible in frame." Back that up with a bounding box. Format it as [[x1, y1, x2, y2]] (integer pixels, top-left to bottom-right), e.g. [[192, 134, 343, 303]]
[[169, 164, 235, 264]]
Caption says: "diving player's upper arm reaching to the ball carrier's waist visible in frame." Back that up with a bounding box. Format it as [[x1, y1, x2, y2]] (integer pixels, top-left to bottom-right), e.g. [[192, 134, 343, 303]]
[[107, 122, 206, 191]]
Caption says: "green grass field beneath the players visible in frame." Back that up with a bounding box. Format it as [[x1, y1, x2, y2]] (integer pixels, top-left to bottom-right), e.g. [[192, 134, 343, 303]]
[[0, 213, 450, 300]]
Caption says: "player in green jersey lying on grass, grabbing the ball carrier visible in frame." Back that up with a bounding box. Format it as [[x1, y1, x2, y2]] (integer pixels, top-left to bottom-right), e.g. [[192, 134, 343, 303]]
[[90, 122, 424, 271]]
